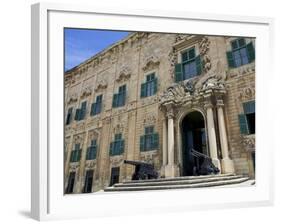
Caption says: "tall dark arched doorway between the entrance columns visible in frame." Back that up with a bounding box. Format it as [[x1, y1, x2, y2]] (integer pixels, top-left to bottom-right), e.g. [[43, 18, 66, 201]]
[[182, 111, 207, 176]]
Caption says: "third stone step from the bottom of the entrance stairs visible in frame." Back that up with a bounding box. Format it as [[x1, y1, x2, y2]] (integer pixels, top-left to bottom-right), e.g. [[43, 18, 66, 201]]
[[123, 173, 235, 184]]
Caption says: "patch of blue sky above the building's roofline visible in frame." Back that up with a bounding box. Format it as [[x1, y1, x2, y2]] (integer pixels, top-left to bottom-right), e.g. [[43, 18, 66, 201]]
[[64, 28, 129, 71]]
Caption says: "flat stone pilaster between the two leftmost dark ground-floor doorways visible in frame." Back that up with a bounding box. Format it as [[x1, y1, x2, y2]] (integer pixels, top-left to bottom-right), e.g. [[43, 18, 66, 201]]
[[76, 131, 89, 193]]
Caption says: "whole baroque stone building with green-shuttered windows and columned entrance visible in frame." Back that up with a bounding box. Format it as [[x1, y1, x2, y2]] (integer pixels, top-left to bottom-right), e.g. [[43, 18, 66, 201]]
[[64, 32, 255, 193]]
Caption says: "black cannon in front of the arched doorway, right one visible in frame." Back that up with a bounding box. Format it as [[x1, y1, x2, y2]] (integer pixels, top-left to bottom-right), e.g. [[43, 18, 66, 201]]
[[191, 149, 220, 175]]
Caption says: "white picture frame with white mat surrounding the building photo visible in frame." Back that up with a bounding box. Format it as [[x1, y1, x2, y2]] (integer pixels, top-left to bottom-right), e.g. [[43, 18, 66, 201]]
[[31, 3, 274, 220]]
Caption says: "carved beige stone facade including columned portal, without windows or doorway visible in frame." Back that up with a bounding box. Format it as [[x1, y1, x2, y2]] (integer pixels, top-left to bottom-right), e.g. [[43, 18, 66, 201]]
[[65, 32, 255, 193]]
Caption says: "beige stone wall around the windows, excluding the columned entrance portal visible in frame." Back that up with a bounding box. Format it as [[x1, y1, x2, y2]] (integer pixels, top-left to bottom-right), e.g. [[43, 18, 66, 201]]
[[65, 33, 255, 193]]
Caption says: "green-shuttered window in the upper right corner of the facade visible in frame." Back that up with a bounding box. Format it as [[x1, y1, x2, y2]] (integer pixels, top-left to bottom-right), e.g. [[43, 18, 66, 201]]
[[226, 38, 255, 68]]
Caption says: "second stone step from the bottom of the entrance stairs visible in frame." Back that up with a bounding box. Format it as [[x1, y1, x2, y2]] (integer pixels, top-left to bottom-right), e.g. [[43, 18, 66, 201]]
[[114, 175, 243, 188]]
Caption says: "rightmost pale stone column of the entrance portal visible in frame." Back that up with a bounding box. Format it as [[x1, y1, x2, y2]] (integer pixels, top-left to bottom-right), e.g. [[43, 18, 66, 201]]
[[217, 100, 234, 173]]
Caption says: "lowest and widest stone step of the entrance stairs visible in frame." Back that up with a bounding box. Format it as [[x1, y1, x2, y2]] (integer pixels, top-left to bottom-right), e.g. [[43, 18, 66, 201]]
[[104, 177, 249, 192]]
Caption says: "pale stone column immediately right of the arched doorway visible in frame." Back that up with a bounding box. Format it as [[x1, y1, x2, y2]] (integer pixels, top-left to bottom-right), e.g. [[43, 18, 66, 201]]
[[205, 102, 221, 170]]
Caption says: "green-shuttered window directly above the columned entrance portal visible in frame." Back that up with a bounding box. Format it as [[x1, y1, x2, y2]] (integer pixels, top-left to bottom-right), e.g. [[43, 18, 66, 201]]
[[175, 47, 202, 82]]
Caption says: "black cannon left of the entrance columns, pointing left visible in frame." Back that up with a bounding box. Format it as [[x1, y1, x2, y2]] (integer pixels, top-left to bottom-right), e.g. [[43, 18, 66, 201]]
[[124, 160, 159, 180]]
